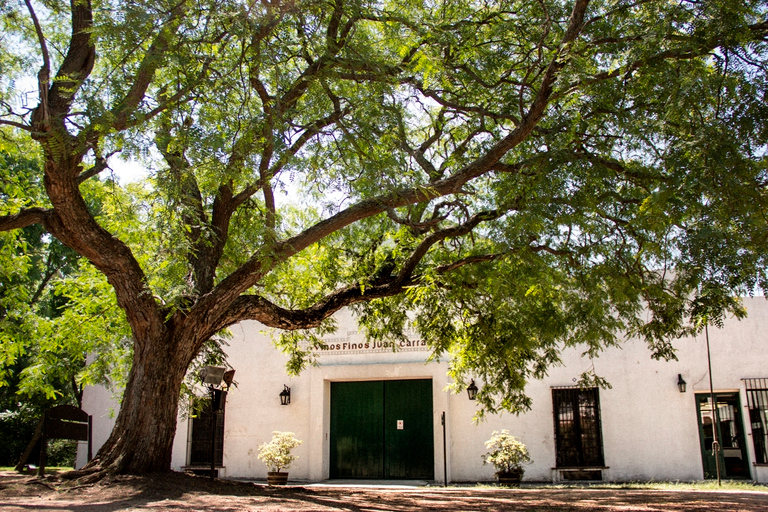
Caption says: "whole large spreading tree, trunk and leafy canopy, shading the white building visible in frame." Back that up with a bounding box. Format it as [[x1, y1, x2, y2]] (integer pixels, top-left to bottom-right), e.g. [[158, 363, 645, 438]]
[[0, 0, 768, 472]]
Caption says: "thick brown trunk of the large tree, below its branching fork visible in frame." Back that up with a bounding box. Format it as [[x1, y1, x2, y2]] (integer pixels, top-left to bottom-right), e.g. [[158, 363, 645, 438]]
[[84, 334, 191, 474]]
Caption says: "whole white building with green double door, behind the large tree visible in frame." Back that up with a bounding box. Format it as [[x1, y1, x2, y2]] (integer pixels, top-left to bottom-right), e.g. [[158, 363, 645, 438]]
[[78, 298, 768, 483]]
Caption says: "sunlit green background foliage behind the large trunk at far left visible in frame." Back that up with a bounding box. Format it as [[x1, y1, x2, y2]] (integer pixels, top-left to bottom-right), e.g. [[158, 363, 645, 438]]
[[0, 143, 134, 466]]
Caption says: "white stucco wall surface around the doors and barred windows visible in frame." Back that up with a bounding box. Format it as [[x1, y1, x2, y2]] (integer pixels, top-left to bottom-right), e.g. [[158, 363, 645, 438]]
[[78, 298, 768, 482]]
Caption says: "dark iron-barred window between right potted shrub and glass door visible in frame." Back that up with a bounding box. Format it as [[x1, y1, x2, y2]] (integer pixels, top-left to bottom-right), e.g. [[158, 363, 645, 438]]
[[552, 387, 604, 468]]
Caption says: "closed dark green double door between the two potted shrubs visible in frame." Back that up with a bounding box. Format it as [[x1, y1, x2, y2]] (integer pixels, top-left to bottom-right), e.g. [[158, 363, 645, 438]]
[[330, 379, 435, 480]]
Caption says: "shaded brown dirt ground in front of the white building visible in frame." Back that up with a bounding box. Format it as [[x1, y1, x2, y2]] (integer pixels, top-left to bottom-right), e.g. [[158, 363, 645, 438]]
[[0, 471, 768, 512]]
